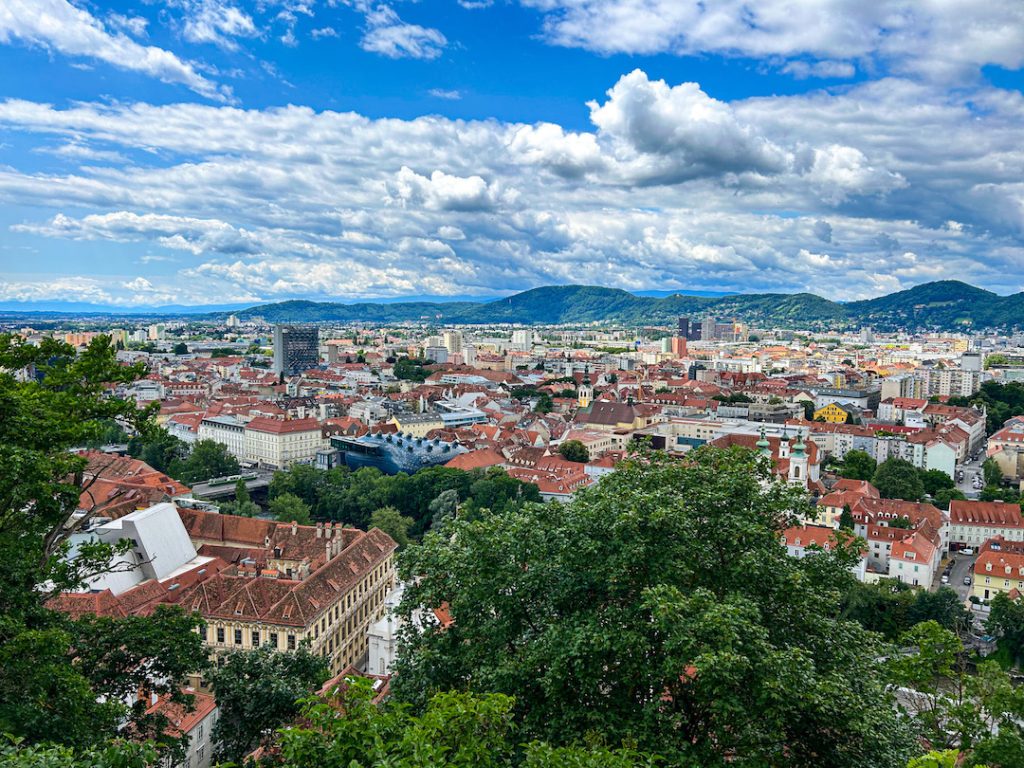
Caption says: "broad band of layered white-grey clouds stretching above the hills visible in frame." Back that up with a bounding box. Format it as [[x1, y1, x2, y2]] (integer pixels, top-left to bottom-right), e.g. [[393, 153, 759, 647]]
[[0, 73, 1024, 303]]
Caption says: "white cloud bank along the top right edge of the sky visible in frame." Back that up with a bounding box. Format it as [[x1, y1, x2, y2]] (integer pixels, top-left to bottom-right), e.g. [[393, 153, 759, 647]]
[[521, 0, 1024, 78]]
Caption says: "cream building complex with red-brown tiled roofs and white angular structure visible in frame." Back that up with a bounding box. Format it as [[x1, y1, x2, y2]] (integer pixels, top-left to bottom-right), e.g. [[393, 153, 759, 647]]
[[52, 503, 397, 674]]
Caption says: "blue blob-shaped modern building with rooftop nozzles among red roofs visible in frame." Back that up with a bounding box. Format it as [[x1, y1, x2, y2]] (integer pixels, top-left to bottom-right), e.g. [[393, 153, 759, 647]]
[[316, 432, 468, 475]]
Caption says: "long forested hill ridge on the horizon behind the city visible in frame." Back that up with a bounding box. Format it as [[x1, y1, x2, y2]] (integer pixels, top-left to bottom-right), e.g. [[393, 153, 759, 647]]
[[237, 281, 1024, 330]]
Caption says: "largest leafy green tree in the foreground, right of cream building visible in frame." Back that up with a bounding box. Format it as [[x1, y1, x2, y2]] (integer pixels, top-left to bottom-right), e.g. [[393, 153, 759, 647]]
[[393, 447, 912, 768]]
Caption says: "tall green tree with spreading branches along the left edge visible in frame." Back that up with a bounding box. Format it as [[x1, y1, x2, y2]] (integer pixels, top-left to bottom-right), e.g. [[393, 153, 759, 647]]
[[0, 335, 205, 749]]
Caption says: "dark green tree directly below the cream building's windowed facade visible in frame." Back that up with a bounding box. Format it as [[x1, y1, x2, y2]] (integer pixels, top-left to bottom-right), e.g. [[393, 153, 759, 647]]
[[207, 645, 328, 763]]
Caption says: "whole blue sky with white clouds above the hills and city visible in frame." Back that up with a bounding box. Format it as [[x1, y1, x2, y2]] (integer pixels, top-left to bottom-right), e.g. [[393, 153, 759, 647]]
[[0, 0, 1024, 308]]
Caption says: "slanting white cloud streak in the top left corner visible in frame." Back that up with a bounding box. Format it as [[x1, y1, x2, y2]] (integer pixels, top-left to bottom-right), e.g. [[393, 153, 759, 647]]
[[0, 0, 230, 101]]
